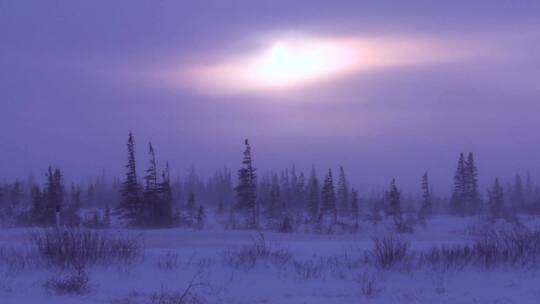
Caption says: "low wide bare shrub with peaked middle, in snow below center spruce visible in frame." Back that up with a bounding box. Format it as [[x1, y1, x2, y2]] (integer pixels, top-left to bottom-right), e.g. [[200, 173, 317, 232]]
[[223, 233, 291, 270]]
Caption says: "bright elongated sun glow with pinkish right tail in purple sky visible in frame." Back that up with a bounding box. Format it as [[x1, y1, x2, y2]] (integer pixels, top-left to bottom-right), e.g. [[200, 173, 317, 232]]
[[178, 37, 465, 94]]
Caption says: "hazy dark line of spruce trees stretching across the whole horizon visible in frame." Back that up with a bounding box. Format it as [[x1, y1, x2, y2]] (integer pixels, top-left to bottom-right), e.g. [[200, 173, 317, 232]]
[[0, 132, 540, 233]]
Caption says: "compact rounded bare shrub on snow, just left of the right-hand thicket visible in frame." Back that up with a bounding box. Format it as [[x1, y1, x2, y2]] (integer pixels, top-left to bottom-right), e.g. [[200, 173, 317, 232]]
[[370, 236, 410, 269]]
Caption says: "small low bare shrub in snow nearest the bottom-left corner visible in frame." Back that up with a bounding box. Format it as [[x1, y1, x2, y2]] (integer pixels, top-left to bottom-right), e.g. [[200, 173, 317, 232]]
[[43, 270, 90, 295]]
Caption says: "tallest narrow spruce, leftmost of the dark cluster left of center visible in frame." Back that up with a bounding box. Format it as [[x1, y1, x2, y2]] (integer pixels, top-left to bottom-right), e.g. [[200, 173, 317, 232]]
[[116, 132, 142, 227]]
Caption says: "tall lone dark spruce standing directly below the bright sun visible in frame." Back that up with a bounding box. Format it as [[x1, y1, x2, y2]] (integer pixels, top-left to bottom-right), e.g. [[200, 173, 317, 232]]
[[235, 139, 258, 229]]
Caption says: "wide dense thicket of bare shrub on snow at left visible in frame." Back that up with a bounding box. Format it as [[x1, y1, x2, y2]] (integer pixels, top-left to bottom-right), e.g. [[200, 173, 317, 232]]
[[30, 228, 143, 268]]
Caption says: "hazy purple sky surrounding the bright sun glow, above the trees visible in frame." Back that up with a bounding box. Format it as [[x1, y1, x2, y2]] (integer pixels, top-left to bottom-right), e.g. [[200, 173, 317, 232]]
[[0, 0, 540, 191]]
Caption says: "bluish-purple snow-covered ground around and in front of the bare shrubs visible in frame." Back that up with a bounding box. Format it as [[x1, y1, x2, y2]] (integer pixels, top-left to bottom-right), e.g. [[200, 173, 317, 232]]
[[0, 217, 540, 304]]
